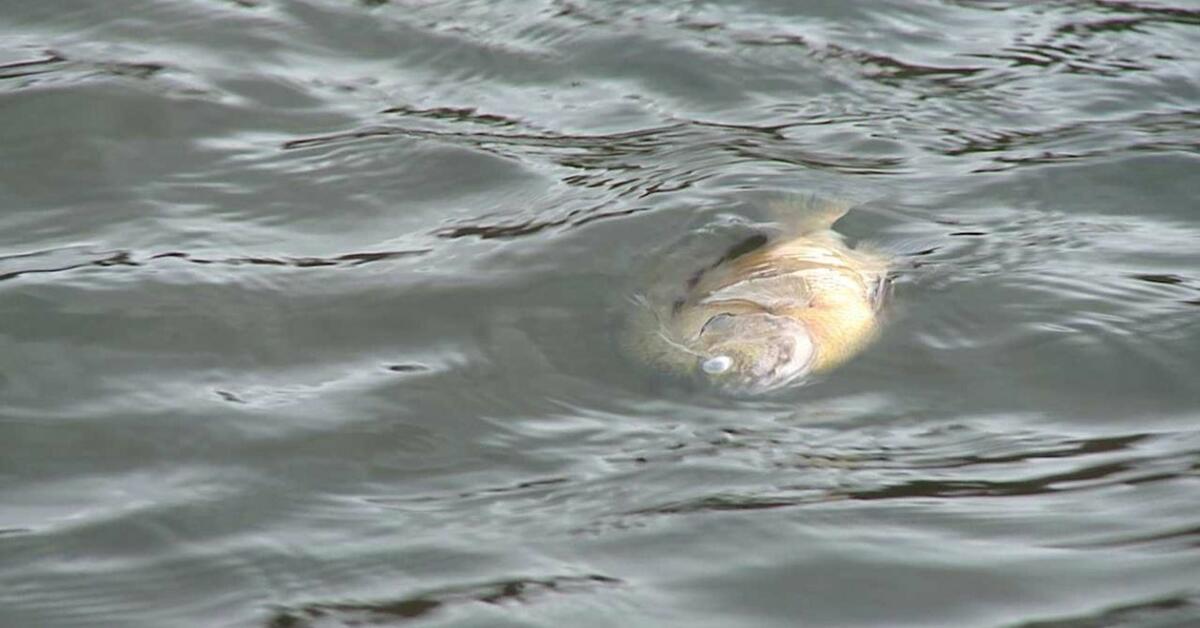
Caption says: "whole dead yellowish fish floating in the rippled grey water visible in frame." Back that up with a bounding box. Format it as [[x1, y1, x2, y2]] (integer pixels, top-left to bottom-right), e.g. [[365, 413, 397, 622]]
[[624, 198, 888, 393]]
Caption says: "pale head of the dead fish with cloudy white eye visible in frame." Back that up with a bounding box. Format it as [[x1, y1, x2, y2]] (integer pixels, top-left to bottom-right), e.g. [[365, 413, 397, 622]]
[[696, 312, 816, 393]]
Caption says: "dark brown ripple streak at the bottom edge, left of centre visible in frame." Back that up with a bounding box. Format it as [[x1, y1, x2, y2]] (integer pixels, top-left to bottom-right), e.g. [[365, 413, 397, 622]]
[[266, 574, 624, 628]]
